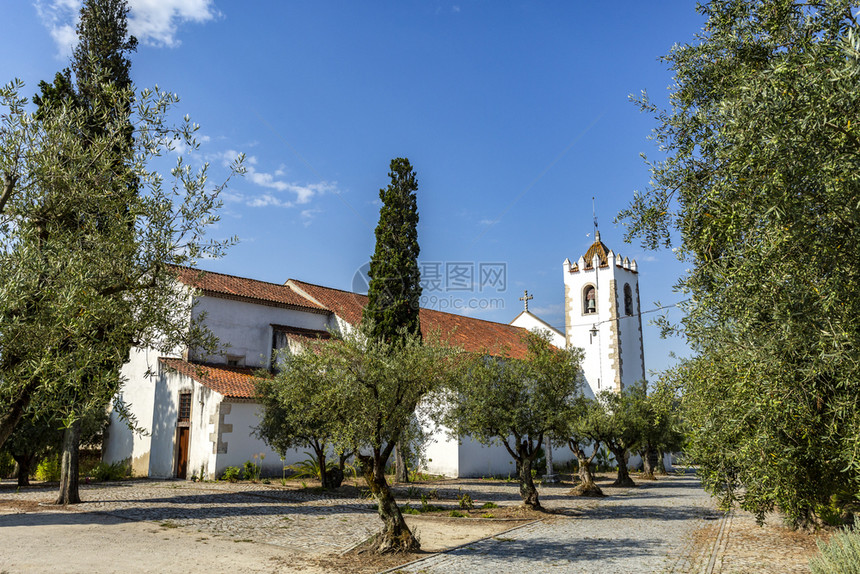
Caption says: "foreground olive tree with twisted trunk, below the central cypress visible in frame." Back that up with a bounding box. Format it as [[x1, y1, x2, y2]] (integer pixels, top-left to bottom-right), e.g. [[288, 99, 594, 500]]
[[263, 328, 457, 552]]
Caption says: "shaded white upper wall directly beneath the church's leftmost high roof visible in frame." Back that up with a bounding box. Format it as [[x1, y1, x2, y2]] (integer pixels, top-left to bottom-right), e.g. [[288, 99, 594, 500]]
[[191, 297, 329, 367]]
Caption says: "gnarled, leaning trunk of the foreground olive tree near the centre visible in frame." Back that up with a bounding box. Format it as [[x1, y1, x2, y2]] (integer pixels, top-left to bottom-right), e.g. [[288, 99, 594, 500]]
[[356, 452, 421, 554]]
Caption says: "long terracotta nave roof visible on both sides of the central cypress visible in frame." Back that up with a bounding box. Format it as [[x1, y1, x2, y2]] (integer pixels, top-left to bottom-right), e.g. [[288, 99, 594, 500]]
[[287, 279, 526, 358]]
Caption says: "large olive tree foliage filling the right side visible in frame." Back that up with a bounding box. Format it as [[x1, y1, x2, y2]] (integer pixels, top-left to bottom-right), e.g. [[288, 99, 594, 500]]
[[620, 0, 860, 524]]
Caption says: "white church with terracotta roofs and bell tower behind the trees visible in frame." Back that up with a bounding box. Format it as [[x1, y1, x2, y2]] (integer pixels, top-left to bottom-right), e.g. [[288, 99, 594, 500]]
[[103, 235, 645, 479]]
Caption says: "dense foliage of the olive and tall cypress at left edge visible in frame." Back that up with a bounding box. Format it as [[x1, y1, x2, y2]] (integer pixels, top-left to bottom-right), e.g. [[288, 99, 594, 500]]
[[0, 0, 241, 445]]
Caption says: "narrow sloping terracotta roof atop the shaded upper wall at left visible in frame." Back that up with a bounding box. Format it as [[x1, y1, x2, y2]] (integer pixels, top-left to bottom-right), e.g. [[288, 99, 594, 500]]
[[174, 266, 325, 312]]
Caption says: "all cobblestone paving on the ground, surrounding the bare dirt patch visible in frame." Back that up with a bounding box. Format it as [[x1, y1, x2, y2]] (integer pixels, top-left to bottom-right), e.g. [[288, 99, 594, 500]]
[[0, 475, 815, 574]]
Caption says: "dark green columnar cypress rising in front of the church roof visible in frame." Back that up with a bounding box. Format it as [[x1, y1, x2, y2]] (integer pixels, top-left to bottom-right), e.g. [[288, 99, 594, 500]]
[[363, 158, 421, 341]]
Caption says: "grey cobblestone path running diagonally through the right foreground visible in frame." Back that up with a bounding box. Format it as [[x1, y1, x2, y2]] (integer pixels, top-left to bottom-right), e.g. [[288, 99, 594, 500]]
[[396, 476, 723, 574]]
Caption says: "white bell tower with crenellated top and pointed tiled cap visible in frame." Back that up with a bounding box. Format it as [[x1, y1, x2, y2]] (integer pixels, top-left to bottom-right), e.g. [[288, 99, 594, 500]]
[[562, 229, 645, 395]]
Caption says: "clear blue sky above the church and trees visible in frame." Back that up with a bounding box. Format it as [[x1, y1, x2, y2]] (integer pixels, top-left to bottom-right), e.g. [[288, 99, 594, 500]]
[[0, 0, 702, 376]]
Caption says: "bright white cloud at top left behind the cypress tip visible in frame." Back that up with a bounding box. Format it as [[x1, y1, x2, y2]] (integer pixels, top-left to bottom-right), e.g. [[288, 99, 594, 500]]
[[35, 0, 221, 58]]
